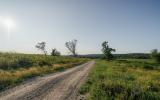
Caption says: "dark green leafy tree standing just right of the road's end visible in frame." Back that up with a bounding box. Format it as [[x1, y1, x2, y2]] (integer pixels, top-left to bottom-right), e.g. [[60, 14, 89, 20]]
[[102, 41, 116, 60]]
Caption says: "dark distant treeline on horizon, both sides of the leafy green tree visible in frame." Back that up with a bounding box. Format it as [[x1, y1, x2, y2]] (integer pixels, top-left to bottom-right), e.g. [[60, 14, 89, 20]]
[[79, 53, 151, 59]]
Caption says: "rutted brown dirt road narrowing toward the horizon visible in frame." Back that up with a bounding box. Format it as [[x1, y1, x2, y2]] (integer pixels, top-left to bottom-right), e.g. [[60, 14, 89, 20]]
[[0, 61, 95, 100]]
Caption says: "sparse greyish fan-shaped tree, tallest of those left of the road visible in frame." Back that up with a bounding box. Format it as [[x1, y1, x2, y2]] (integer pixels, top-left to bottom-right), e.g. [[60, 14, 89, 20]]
[[65, 39, 77, 57]]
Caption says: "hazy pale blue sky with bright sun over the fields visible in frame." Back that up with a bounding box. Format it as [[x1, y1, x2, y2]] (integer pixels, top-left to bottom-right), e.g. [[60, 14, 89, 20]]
[[0, 0, 160, 54]]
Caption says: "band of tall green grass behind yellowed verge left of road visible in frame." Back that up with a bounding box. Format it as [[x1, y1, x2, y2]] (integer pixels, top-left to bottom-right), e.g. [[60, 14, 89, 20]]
[[0, 53, 89, 70]]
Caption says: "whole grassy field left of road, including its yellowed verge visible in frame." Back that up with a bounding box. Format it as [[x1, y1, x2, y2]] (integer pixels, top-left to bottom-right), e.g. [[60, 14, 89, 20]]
[[0, 53, 88, 91]]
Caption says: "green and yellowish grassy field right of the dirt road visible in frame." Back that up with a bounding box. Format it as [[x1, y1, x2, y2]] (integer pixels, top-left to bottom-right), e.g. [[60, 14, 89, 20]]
[[79, 59, 160, 100]]
